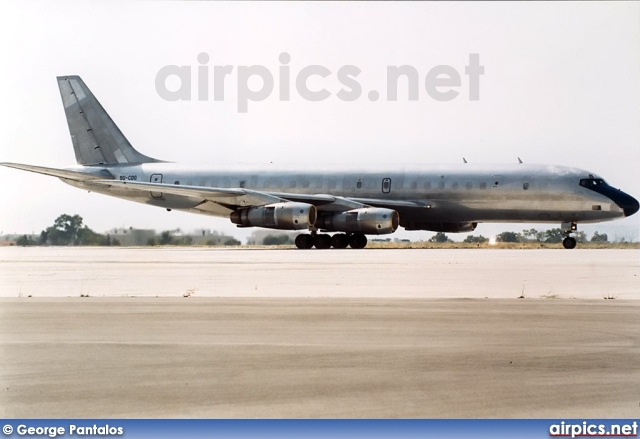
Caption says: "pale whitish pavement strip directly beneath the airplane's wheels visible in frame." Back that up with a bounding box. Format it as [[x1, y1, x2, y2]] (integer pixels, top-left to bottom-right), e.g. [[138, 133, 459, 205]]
[[0, 247, 640, 300]]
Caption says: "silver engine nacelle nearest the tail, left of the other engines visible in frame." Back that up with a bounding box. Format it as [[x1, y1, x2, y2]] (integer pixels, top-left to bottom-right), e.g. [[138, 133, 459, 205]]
[[230, 202, 318, 230]]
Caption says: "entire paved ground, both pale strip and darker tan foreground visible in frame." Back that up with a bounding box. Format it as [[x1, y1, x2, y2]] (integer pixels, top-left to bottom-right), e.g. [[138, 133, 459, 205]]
[[0, 249, 640, 418]]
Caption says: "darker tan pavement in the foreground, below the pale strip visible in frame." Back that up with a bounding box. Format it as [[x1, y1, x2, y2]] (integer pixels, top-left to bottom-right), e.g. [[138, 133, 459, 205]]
[[0, 298, 640, 418]]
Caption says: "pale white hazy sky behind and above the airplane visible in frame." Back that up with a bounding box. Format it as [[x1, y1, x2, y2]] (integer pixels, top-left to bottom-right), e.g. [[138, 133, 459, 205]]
[[0, 1, 640, 242]]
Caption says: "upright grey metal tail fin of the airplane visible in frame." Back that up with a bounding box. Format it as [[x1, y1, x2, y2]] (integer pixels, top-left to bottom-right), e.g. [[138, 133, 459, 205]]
[[57, 76, 160, 165]]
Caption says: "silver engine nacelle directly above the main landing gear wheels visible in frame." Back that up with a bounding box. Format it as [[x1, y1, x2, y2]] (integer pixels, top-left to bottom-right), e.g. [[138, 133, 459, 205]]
[[316, 207, 400, 235]]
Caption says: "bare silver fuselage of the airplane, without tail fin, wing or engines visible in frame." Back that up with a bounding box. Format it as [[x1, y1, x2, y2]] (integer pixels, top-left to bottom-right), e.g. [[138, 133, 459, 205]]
[[65, 163, 625, 229]]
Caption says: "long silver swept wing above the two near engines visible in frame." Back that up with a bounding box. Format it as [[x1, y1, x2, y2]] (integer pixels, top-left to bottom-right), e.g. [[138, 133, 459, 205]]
[[91, 180, 378, 212]]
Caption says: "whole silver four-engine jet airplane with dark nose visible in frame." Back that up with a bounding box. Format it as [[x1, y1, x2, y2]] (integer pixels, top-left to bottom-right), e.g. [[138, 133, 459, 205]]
[[0, 76, 638, 249]]
